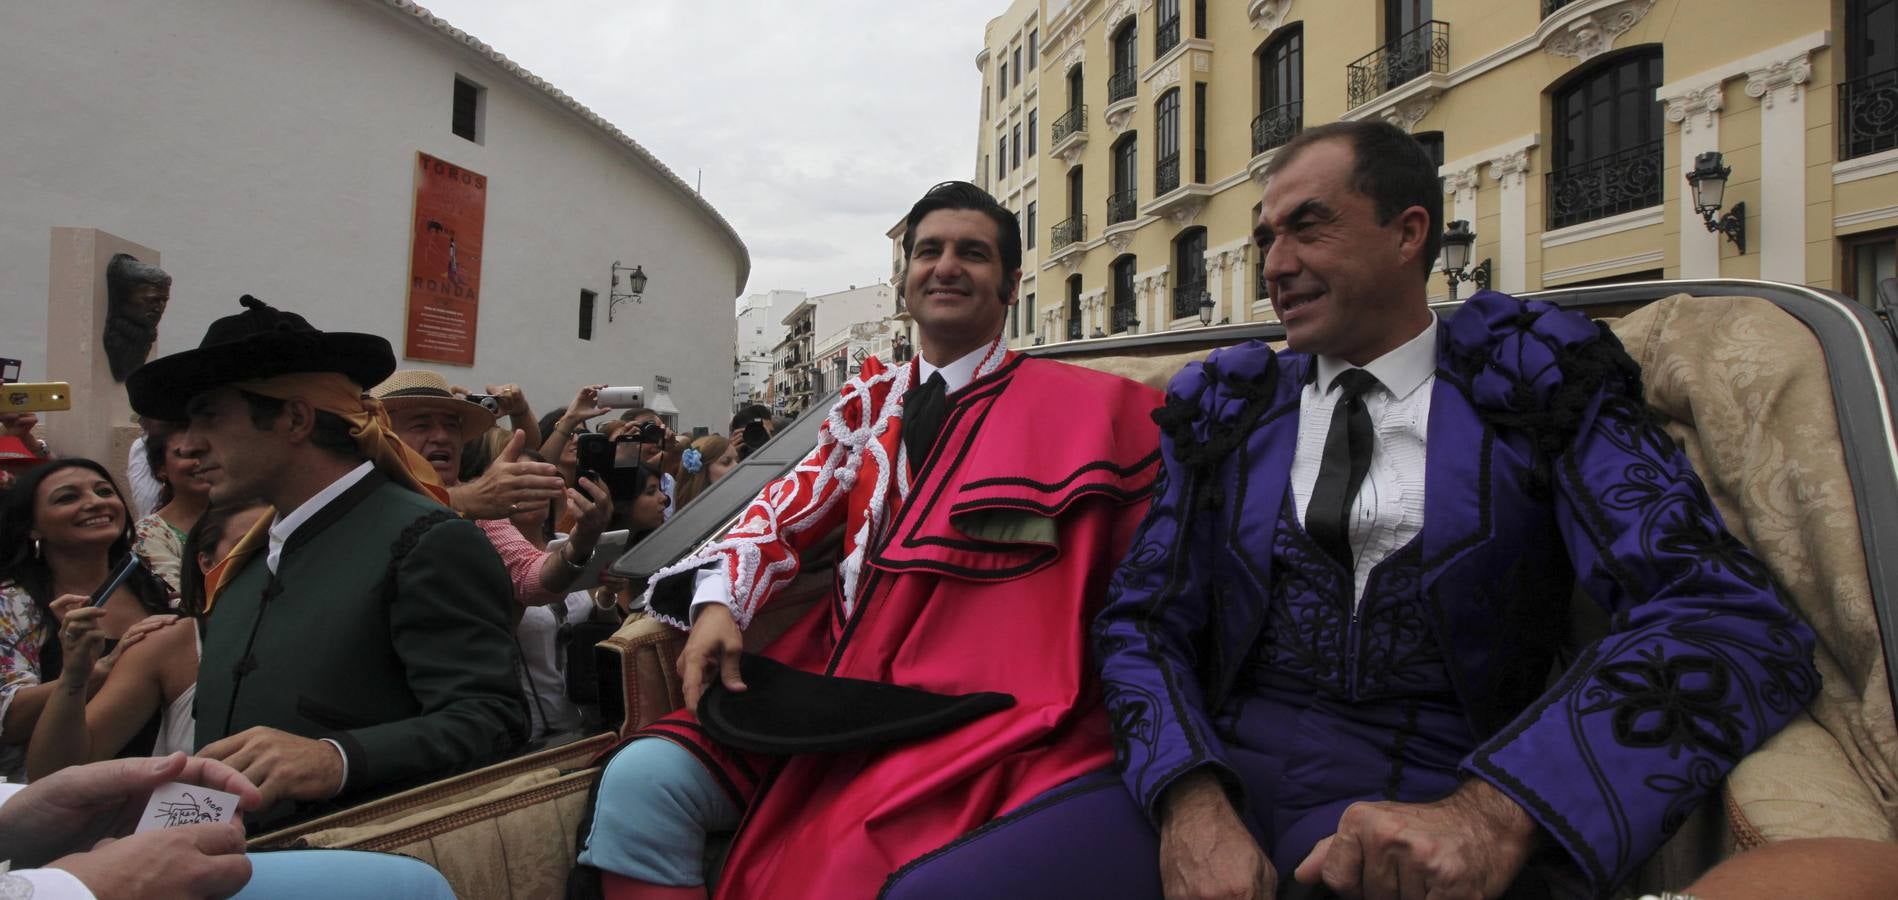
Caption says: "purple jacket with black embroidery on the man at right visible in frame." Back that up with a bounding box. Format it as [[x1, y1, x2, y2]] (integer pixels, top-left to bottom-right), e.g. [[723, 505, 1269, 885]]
[[1095, 292, 1818, 891]]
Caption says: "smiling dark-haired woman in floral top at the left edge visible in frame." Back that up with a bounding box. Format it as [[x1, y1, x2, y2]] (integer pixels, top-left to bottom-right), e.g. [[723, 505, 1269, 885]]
[[0, 459, 171, 778]]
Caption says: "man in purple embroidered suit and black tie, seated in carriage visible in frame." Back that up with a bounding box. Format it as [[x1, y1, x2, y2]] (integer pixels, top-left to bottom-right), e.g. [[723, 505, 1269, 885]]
[[873, 122, 1818, 900]]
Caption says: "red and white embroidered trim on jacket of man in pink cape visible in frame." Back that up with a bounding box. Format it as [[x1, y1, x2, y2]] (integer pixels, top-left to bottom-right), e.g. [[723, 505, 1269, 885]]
[[647, 336, 1008, 628]]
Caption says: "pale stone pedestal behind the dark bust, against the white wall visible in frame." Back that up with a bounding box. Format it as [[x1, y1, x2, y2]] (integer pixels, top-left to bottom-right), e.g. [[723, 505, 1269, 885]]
[[40, 228, 159, 490]]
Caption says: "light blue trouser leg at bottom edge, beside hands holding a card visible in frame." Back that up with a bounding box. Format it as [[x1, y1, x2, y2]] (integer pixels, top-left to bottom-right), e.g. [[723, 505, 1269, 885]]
[[232, 851, 456, 900]]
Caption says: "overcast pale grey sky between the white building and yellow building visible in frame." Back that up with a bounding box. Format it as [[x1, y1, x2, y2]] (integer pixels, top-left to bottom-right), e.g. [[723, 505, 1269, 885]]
[[423, 0, 1008, 307]]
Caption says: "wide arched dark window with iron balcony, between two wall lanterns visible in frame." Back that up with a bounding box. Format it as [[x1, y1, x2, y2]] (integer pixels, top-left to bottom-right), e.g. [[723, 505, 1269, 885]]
[[1547, 47, 1663, 228]]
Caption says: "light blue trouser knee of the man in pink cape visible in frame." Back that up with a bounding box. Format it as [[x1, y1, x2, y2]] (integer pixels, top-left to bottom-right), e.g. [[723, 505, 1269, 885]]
[[581, 737, 742, 887]]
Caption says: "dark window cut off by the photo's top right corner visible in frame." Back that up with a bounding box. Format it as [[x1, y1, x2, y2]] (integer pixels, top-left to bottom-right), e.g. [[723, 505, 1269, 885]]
[[1839, 0, 1898, 159]]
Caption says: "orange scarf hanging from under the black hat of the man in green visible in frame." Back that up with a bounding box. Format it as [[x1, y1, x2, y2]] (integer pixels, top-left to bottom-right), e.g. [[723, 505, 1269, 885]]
[[205, 372, 448, 613]]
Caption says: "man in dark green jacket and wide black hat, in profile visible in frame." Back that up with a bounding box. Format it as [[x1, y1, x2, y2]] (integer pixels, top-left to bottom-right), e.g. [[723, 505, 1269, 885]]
[[125, 296, 526, 824]]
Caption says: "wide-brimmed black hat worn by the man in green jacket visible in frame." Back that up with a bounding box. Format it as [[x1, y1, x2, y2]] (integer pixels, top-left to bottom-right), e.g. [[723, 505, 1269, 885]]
[[125, 294, 395, 422]]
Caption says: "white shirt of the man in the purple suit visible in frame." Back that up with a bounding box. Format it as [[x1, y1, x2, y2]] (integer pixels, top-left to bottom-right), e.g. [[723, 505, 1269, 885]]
[[1293, 315, 1437, 606]]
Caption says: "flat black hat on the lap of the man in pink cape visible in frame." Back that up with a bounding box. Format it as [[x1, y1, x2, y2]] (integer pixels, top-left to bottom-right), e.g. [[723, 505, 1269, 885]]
[[698, 653, 1015, 756]]
